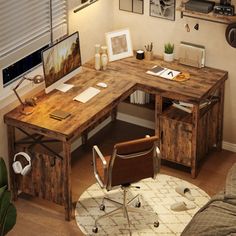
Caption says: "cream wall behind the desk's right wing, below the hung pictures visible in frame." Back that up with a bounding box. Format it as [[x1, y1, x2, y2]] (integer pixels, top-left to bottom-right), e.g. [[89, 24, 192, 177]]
[[113, 0, 236, 146]]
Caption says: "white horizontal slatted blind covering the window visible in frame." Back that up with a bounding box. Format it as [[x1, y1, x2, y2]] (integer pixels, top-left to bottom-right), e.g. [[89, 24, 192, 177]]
[[0, 0, 67, 61]]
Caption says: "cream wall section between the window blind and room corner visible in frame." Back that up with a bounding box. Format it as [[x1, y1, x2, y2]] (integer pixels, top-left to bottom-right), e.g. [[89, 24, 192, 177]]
[[68, 0, 113, 63]]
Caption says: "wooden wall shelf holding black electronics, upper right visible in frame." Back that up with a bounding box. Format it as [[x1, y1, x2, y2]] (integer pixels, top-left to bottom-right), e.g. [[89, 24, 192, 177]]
[[177, 7, 236, 24]]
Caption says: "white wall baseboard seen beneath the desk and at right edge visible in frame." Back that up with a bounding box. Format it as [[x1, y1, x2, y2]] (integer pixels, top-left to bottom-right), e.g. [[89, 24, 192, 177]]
[[71, 112, 236, 152]]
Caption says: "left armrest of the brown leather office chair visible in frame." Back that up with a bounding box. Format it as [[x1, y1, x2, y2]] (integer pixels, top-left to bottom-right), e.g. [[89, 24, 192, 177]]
[[93, 145, 108, 188]]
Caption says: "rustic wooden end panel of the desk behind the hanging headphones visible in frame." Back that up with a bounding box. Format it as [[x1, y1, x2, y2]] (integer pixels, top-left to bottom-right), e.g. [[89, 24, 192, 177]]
[[16, 150, 64, 205]]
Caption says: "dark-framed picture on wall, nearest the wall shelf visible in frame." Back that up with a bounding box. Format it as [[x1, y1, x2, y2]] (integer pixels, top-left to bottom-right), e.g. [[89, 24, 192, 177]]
[[149, 0, 176, 21]]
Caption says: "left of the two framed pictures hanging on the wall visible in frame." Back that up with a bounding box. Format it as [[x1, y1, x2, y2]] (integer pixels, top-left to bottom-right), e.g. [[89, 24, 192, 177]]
[[119, 0, 144, 14]]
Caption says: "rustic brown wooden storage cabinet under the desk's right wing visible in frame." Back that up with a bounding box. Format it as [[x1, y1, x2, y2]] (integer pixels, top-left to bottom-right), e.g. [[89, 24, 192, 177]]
[[160, 102, 218, 172]]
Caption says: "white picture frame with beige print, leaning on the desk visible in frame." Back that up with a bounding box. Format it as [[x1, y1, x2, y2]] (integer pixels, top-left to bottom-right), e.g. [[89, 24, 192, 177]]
[[105, 29, 133, 61]]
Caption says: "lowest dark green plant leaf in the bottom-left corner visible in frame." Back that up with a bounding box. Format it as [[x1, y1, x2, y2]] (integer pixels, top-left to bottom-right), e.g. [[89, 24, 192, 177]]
[[0, 203, 16, 235]]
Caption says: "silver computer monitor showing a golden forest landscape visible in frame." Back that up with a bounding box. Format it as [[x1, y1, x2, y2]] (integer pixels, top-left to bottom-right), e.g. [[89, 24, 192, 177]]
[[42, 32, 82, 93]]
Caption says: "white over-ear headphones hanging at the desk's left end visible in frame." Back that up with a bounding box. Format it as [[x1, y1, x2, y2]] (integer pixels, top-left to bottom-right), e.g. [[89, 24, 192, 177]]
[[12, 152, 31, 175]]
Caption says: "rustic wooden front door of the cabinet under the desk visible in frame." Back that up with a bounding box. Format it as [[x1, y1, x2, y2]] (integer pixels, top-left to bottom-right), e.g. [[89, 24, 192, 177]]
[[160, 117, 192, 166]]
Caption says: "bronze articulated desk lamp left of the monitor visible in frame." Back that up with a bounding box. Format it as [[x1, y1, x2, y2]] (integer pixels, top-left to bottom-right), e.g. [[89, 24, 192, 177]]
[[13, 75, 44, 115]]
